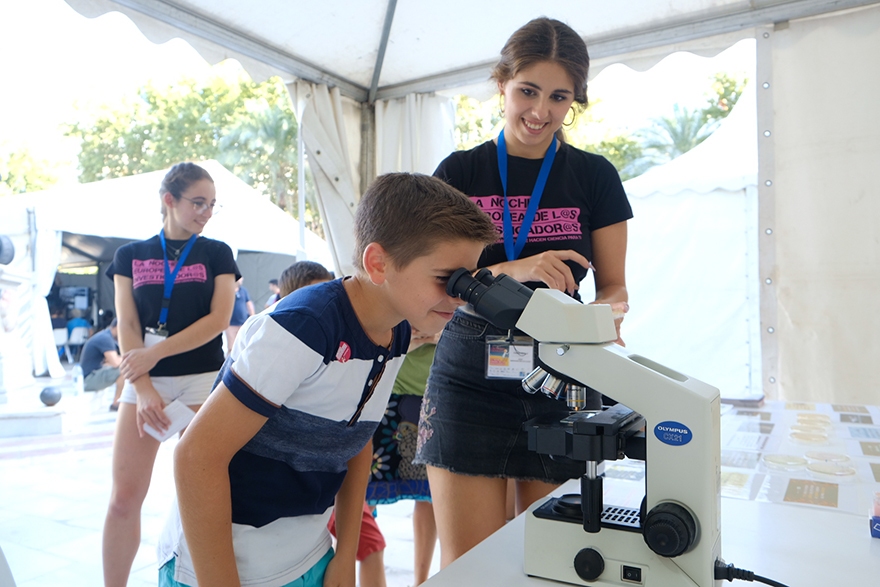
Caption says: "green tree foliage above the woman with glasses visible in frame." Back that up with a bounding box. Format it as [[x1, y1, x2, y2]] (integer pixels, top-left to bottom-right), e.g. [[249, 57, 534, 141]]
[[66, 76, 322, 234]]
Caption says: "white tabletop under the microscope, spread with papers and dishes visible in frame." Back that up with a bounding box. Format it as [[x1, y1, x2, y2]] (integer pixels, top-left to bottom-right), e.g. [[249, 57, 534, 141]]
[[426, 402, 880, 587]]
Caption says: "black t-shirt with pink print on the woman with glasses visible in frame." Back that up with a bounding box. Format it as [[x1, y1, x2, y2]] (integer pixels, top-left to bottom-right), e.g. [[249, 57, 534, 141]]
[[107, 235, 241, 377]]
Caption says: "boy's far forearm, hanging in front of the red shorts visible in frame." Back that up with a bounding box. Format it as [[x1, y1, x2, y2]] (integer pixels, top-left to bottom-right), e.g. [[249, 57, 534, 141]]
[[324, 446, 373, 587]]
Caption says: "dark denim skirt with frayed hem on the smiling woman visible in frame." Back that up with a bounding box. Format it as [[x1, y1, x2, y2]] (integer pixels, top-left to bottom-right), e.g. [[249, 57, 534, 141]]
[[414, 310, 586, 483]]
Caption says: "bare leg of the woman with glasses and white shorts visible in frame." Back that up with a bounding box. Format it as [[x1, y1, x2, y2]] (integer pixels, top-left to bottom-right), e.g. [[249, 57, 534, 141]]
[[103, 403, 159, 587]]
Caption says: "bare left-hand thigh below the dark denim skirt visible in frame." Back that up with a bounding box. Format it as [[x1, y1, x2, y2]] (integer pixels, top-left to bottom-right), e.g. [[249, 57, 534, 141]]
[[428, 465, 507, 568]]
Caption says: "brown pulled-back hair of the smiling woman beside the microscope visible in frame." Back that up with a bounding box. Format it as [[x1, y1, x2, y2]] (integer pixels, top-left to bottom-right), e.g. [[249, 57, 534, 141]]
[[491, 17, 590, 116]]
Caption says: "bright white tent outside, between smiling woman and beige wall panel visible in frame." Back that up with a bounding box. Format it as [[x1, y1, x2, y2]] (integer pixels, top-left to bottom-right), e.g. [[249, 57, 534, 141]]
[[623, 88, 762, 398]]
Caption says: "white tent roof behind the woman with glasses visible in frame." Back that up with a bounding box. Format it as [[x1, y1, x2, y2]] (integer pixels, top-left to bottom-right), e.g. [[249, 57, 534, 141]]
[[0, 161, 332, 267]]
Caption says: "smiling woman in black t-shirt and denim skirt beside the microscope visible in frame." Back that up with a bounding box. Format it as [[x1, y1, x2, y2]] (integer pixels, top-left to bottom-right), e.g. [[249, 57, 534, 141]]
[[416, 18, 632, 566]]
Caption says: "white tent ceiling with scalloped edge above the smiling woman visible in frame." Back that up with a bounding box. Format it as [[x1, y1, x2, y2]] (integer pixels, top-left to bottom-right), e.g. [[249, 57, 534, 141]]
[[66, 0, 876, 102]]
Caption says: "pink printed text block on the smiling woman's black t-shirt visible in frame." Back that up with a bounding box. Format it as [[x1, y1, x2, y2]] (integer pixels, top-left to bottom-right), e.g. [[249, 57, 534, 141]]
[[471, 196, 583, 243]]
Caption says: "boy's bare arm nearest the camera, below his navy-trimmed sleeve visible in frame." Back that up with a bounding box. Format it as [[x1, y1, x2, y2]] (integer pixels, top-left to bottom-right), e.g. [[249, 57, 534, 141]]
[[174, 383, 268, 587]]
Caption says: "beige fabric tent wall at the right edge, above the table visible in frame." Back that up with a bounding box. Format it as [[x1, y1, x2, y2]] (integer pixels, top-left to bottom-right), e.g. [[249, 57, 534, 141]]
[[761, 6, 880, 404]]
